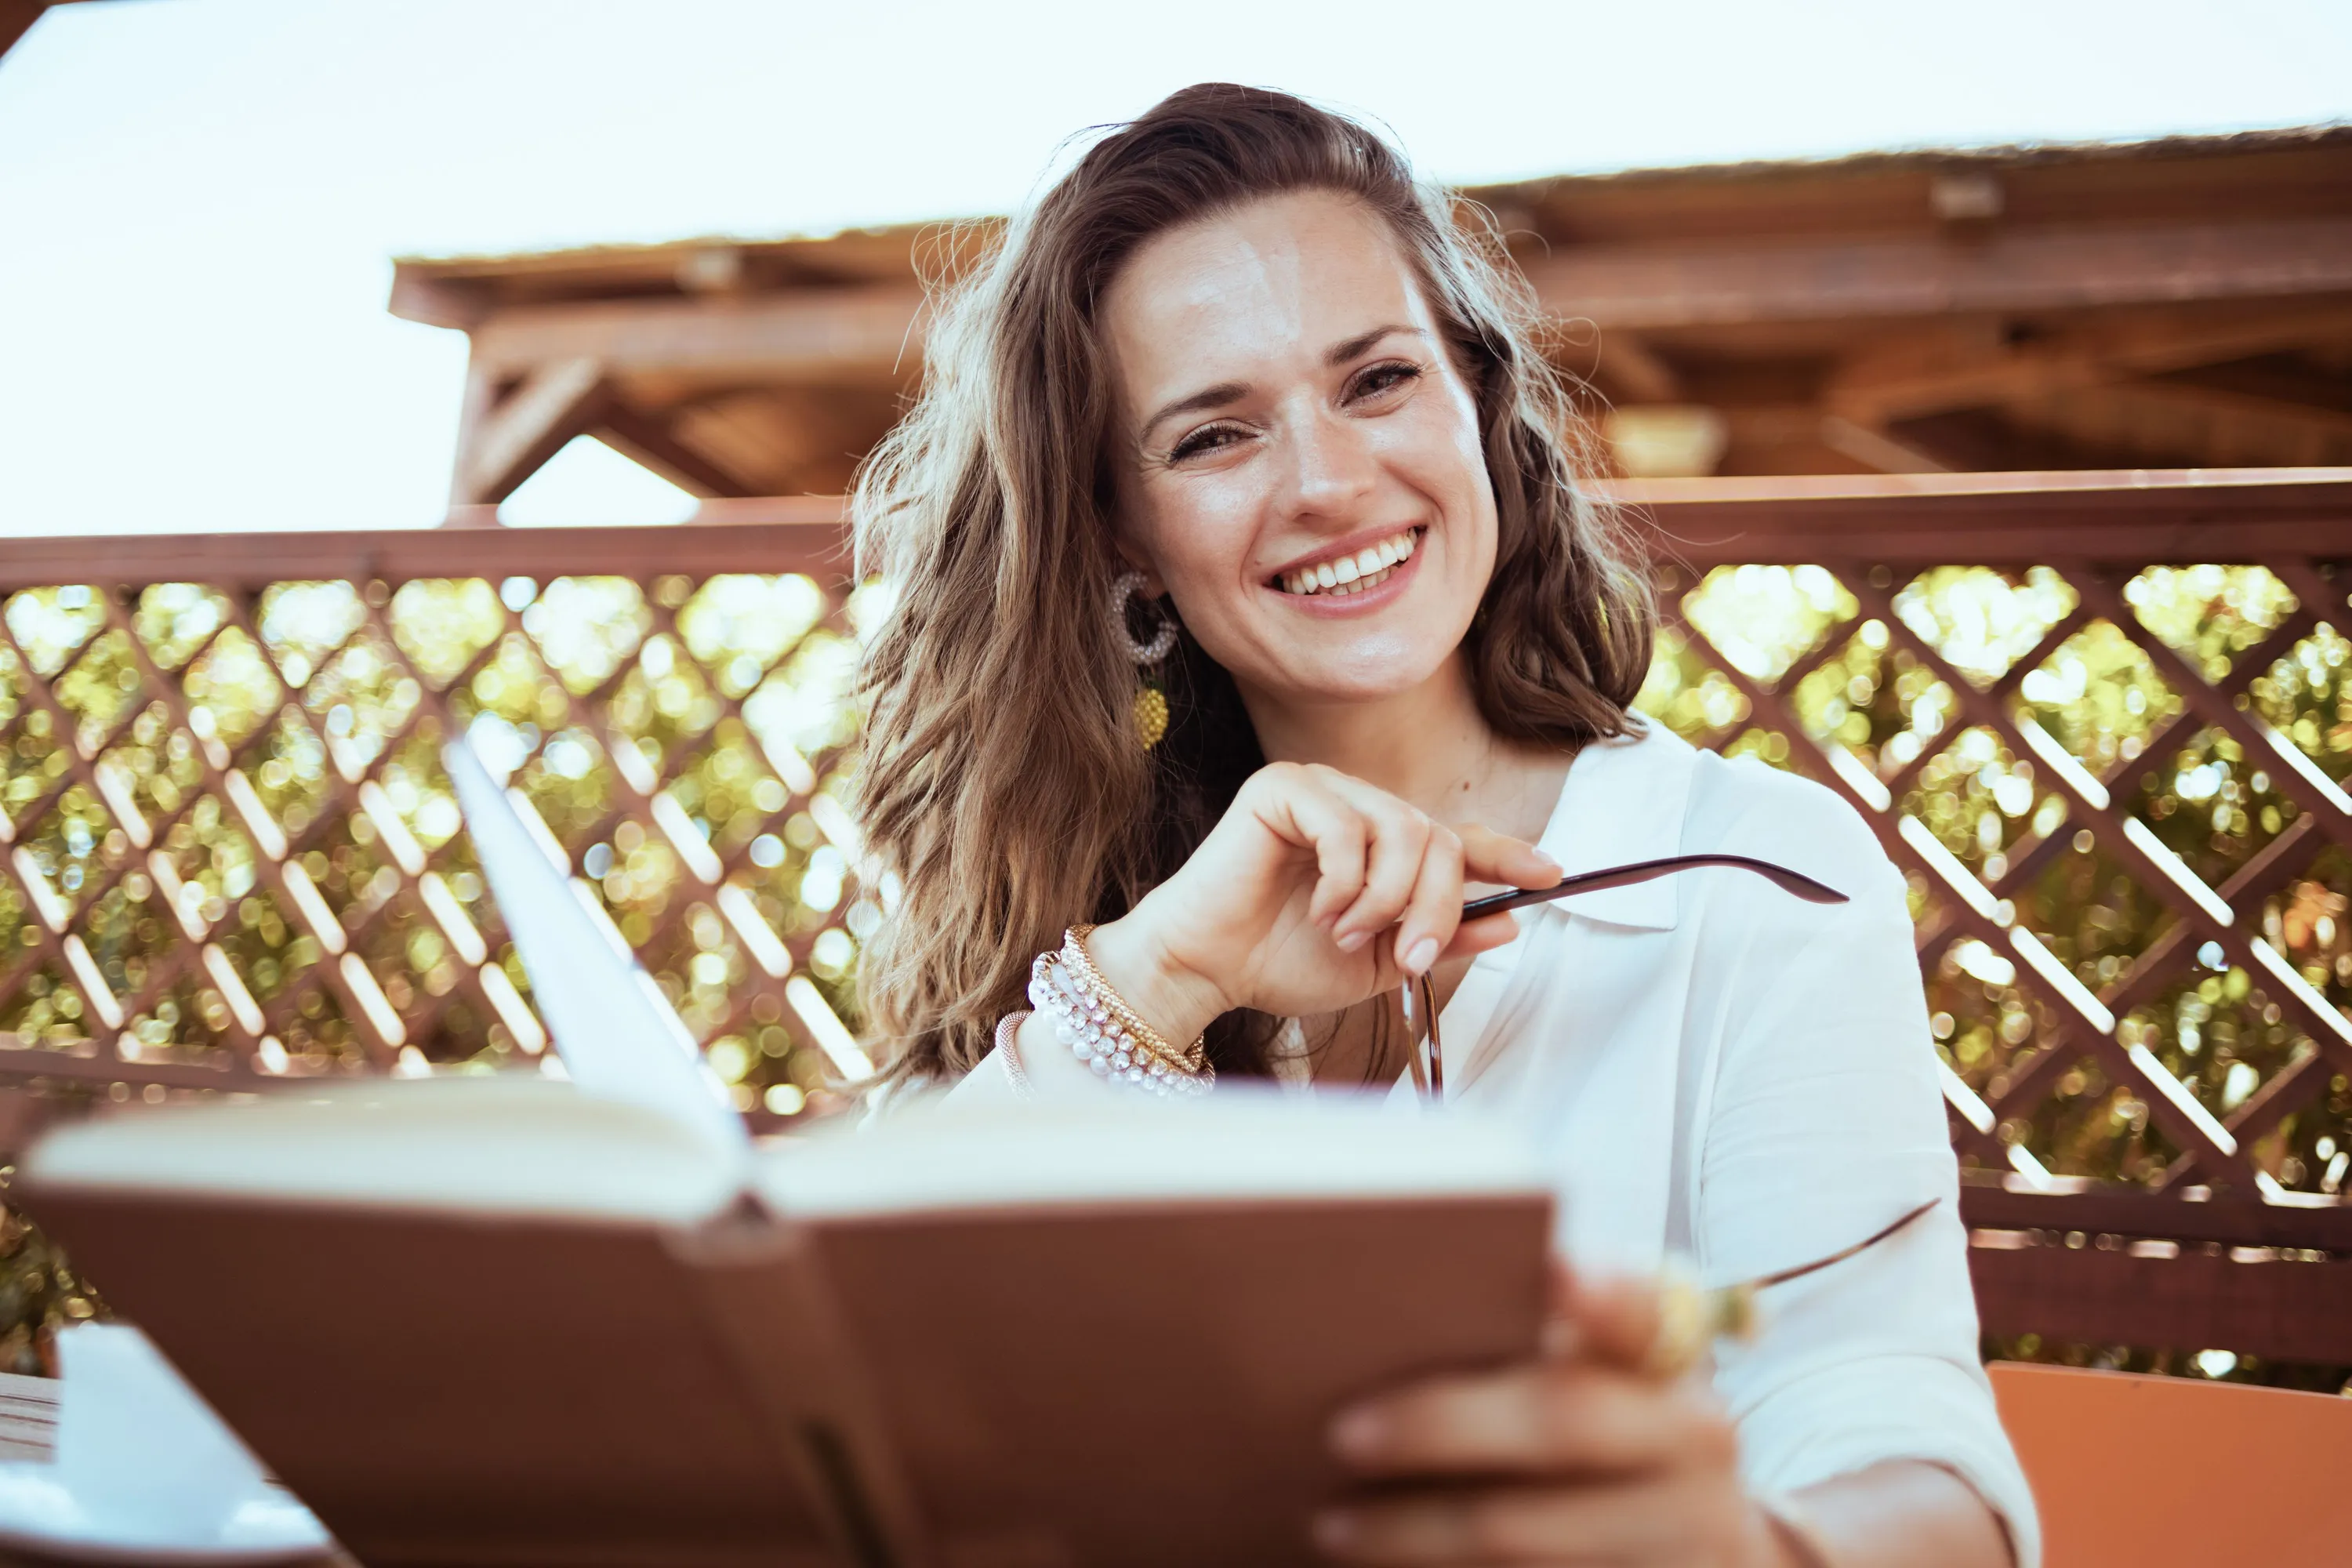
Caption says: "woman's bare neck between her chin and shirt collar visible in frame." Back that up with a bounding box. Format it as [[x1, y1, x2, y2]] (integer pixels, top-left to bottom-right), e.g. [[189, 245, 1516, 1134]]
[[1242, 654, 1569, 841]]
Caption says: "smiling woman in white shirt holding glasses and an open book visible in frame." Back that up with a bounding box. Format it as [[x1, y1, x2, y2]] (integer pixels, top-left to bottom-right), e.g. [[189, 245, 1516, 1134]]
[[856, 87, 2034, 1568]]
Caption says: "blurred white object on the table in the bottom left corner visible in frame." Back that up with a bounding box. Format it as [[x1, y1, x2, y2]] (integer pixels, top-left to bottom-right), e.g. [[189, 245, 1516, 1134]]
[[0, 1323, 334, 1563]]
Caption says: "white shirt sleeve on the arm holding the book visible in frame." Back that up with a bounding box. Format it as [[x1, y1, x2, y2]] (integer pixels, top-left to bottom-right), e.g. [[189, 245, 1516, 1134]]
[[1691, 792, 2042, 1568]]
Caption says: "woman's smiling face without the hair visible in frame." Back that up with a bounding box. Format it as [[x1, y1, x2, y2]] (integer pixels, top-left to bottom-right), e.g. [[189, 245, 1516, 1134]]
[[1101, 193, 1496, 703]]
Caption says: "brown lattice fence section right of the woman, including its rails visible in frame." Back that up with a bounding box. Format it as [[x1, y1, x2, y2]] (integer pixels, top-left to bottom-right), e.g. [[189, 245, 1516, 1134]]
[[1642, 473, 2352, 1366]]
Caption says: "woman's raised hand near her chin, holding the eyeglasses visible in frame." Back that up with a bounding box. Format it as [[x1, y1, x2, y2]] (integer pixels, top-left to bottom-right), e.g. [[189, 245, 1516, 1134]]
[[1087, 762, 1559, 1046]]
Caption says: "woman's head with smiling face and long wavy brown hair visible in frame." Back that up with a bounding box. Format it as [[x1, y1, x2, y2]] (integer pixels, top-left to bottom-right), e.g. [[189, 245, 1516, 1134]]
[[854, 87, 1653, 1076]]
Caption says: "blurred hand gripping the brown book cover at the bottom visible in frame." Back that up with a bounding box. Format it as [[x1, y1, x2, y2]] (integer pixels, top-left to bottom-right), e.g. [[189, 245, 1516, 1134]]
[[1315, 1276, 1790, 1568]]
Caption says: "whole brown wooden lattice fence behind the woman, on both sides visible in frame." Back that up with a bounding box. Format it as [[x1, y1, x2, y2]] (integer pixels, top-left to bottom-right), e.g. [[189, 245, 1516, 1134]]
[[0, 473, 2352, 1363]]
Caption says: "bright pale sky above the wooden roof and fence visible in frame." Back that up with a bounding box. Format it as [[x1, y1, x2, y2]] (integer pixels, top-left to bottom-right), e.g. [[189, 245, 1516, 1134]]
[[0, 0, 2352, 534]]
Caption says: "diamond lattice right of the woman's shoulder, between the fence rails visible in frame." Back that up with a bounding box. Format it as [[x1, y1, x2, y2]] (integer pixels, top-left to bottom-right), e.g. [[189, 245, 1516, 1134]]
[[1642, 562, 2352, 1201]]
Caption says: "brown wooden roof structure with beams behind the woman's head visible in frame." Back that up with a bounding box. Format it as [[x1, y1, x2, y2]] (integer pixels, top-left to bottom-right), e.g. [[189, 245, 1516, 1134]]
[[390, 127, 2352, 506]]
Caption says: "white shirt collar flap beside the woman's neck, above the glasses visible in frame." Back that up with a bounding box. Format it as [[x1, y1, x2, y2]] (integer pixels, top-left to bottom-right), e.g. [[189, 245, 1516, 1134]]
[[1538, 713, 1698, 931]]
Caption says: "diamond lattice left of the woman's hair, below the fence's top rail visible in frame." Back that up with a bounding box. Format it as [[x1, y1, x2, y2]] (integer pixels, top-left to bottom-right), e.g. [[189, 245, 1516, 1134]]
[[0, 576, 882, 1121]]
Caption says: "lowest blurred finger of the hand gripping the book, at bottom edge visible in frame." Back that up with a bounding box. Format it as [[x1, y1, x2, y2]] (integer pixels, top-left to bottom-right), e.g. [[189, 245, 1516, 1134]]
[[1315, 1476, 1745, 1568]]
